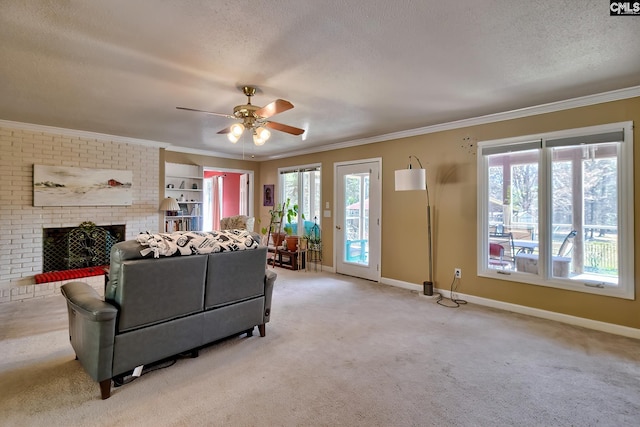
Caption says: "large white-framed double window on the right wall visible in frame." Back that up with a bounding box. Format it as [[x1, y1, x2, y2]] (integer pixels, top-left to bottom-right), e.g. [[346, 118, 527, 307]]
[[478, 123, 634, 299]]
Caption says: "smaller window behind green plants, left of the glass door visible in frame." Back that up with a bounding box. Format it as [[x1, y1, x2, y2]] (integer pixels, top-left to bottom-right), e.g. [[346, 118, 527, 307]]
[[279, 165, 321, 236]]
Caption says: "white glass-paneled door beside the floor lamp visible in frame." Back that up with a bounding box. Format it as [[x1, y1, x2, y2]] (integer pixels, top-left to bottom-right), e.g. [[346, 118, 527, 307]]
[[334, 158, 382, 282]]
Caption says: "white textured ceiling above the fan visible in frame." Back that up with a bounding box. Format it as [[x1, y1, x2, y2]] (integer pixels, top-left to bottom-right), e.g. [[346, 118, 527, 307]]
[[0, 0, 640, 158]]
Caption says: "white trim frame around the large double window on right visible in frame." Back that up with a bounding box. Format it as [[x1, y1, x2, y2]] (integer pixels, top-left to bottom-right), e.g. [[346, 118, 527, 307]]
[[477, 121, 635, 300]]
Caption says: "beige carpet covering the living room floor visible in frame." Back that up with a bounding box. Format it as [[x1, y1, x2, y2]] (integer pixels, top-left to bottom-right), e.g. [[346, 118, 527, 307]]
[[0, 269, 640, 426]]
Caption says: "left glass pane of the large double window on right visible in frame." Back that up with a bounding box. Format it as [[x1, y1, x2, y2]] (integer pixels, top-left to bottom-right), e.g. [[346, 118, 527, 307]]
[[487, 149, 540, 274]]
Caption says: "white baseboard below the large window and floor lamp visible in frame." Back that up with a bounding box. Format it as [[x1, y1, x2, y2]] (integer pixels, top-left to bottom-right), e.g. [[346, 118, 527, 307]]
[[381, 278, 640, 339]]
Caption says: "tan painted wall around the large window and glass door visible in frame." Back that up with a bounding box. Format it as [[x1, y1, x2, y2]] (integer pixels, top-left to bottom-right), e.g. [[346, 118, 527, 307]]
[[258, 98, 640, 328]]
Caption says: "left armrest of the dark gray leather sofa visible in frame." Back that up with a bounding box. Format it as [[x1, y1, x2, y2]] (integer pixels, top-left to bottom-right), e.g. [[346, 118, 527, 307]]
[[61, 282, 118, 381]]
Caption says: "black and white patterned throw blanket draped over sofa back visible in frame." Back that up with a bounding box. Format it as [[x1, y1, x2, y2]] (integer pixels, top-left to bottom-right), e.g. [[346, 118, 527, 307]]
[[136, 230, 258, 258]]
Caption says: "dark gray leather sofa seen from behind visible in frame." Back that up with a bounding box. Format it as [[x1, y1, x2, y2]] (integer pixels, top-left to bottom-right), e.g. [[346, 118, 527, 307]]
[[62, 240, 276, 399]]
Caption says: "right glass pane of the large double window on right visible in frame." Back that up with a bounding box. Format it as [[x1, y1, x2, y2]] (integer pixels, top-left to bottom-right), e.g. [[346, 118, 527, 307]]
[[551, 143, 618, 285]]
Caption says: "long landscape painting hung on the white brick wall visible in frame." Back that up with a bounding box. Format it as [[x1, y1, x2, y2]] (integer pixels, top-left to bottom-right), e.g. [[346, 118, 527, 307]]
[[33, 165, 133, 206]]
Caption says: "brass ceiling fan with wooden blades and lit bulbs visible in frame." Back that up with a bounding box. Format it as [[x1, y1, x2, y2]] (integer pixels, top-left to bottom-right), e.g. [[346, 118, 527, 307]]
[[176, 86, 304, 146]]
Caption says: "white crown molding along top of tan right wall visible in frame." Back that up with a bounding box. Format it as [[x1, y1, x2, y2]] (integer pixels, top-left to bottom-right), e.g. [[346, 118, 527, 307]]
[[261, 86, 640, 160]]
